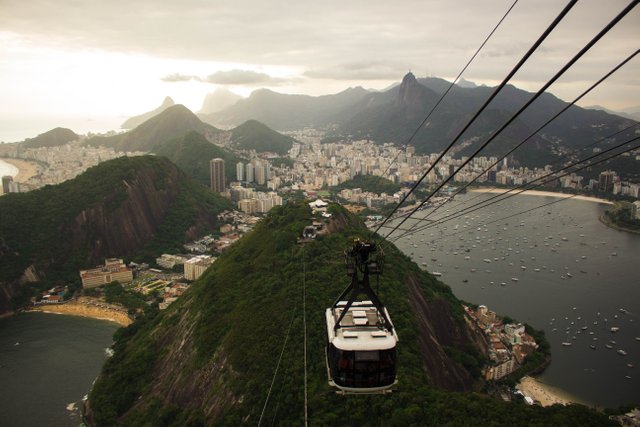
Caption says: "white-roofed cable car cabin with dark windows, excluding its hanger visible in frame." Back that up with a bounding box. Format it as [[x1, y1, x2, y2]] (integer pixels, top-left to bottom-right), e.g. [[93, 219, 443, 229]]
[[326, 301, 398, 394]]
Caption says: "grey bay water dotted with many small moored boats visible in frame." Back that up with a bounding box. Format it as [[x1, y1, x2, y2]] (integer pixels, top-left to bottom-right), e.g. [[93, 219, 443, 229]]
[[396, 193, 640, 407]]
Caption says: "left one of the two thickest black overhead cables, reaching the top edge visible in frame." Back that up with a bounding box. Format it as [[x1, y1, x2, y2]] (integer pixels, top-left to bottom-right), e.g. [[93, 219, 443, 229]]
[[374, 0, 578, 237]]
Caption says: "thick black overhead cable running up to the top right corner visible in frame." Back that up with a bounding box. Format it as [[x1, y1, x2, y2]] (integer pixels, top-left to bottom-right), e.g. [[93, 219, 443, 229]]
[[385, 0, 640, 242]]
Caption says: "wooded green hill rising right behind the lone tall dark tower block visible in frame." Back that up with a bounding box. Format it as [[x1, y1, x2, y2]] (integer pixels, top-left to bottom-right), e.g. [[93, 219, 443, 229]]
[[153, 131, 246, 187]]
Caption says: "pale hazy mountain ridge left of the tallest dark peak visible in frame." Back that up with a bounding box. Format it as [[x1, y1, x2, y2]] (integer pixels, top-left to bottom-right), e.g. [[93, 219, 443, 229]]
[[205, 87, 369, 131]]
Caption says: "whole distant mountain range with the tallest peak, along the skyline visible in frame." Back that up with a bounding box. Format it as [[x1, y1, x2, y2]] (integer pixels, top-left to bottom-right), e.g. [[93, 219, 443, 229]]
[[201, 73, 633, 166]]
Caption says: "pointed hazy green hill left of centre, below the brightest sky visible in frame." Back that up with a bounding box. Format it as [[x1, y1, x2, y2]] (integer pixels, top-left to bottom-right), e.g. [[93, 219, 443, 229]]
[[88, 104, 222, 152]]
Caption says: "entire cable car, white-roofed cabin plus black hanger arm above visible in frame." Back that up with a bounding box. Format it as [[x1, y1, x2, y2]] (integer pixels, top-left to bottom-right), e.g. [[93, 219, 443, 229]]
[[325, 240, 398, 394]]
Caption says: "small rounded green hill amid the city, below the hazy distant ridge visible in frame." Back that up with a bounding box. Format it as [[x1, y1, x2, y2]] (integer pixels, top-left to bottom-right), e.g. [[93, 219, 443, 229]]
[[231, 120, 295, 154]]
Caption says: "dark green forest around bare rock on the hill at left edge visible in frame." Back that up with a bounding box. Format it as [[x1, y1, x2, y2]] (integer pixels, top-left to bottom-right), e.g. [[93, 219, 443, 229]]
[[0, 156, 230, 310]]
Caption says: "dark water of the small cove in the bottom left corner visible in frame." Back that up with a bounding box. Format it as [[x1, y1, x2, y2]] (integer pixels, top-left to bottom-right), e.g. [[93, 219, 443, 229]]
[[0, 313, 118, 426]]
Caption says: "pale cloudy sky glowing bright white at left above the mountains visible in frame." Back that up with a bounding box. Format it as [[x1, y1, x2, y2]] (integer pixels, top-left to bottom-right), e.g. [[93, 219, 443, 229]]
[[0, 0, 640, 142]]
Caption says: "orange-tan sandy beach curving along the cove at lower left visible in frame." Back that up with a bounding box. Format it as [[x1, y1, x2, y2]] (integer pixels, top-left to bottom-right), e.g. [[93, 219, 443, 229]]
[[32, 297, 133, 326]]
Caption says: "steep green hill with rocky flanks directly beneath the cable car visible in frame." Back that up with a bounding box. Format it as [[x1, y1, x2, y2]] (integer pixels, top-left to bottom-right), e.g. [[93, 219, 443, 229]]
[[88, 204, 608, 426]]
